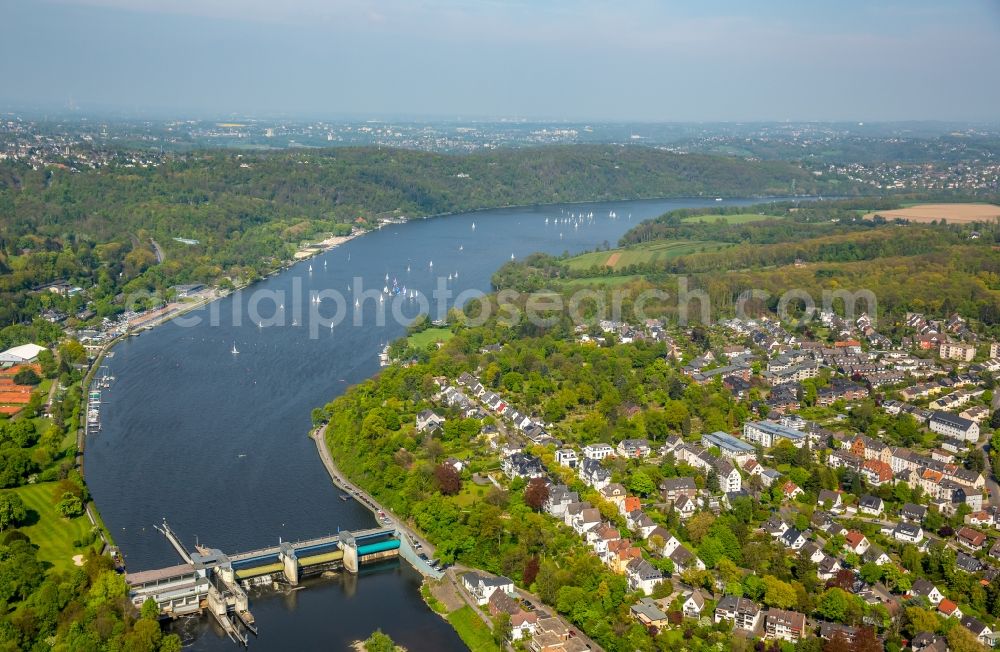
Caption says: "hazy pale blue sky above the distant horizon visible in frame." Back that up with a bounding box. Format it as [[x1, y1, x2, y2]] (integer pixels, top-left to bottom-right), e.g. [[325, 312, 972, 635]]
[[0, 0, 1000, 121]]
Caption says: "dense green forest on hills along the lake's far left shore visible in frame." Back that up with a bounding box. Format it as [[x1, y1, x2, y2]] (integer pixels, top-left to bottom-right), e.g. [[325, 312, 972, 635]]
[[0, 146, 856, 326]]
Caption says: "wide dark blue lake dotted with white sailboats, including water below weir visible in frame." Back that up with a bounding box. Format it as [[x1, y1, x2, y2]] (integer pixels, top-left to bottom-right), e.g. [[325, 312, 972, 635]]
[[86, 200, 748, 651]]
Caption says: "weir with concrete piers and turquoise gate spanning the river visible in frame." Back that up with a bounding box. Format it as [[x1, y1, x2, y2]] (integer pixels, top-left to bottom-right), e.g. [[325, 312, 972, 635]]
[[125, 521, 400, 646]]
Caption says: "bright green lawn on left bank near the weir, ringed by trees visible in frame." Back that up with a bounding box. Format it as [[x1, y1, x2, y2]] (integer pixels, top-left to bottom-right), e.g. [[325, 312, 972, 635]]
[[11, 482, 90, 570]]
